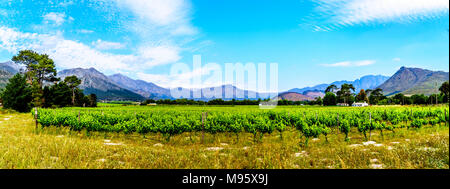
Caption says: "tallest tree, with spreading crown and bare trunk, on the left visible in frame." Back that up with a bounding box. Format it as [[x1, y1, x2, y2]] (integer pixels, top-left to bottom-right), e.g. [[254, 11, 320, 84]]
[[11, 50, 58, 106]]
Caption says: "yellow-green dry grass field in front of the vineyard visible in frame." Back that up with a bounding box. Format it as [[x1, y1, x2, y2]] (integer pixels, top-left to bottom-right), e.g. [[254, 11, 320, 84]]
[[0, 105, 449, 169]]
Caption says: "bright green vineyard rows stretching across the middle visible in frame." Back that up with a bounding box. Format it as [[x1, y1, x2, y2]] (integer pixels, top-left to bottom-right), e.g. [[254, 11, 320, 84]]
[[33, 106, 449, 144]]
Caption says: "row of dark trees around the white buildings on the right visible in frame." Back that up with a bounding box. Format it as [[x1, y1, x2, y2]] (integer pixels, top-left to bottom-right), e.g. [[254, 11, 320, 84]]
[[317, 81, 449, 106]]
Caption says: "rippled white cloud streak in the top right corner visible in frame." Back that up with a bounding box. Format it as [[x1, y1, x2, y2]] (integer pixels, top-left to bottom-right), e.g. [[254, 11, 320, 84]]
[[311, 0, 449, 31]]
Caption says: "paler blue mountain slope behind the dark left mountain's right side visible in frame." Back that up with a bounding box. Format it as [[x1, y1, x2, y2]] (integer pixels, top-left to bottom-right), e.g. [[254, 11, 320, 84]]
[[108, 74, 171, 99]]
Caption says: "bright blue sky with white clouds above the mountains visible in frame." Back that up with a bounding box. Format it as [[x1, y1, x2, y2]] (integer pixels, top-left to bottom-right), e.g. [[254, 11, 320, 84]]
[[0, 0, 449, 91]]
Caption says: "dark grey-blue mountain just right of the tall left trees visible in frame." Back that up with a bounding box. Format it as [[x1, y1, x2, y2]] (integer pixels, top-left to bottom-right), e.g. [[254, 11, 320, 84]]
[[58, 68, 145, 101]]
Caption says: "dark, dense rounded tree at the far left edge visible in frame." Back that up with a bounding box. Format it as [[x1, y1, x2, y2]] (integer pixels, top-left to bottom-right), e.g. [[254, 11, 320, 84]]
[[1, 74, 32, 112]]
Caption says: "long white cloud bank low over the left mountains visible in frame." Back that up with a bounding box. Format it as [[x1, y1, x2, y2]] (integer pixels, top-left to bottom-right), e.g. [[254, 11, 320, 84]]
[[0, 27, 183, 73]]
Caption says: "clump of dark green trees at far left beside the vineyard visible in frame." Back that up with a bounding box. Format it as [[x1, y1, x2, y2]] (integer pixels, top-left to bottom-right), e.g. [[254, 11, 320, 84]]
[[0, 50, 97, 112]]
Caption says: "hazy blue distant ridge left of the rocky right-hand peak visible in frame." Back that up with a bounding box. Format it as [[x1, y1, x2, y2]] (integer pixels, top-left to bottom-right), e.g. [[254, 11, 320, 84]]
[[288, 75, 389, 94]]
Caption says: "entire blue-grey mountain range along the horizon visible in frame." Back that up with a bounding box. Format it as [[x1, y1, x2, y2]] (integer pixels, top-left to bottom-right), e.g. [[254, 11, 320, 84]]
[[0, 62, 449, 101]]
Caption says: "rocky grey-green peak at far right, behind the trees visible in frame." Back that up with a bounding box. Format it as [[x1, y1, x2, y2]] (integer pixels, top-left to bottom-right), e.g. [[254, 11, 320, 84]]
[[379, 67, 449, 96]]
